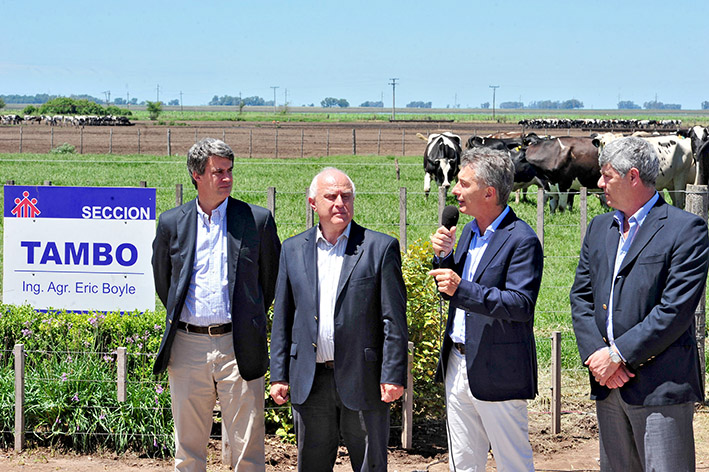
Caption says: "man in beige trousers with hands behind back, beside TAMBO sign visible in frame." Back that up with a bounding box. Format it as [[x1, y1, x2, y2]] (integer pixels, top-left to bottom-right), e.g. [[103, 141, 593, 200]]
[[153, 138, 280, 471]]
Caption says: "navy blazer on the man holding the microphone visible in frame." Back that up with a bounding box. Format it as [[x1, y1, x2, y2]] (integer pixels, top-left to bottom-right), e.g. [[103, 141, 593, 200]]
[[436, 209, 544, 401]]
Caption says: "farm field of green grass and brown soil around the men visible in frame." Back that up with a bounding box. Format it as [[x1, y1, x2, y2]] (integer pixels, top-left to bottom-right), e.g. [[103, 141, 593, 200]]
[[0, 118, 709, 472]]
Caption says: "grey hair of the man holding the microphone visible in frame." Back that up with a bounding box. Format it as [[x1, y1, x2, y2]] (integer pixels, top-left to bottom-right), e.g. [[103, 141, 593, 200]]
[[460, 147, 515, 207]]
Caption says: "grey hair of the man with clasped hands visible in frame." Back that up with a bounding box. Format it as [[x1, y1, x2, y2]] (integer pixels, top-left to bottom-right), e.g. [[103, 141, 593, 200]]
[[598, 136, 660, 187]]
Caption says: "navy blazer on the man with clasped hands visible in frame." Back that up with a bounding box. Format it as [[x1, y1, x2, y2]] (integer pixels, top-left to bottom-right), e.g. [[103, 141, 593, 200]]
[[571, 197, 709, 406]]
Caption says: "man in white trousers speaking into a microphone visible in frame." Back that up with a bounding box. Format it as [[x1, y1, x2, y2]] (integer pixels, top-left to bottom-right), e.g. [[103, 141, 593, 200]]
[[430, 148, 543, 471]]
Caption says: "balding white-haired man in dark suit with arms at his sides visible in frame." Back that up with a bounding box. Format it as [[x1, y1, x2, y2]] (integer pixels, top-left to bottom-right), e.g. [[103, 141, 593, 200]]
[[271, 168, 408, 472]]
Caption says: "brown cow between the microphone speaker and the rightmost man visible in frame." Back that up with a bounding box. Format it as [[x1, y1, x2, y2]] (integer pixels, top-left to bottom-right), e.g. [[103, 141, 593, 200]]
[[525, 136, 601, 212]]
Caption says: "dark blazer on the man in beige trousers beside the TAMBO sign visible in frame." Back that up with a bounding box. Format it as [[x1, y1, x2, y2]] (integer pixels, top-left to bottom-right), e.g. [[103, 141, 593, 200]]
[[153, 197, 281, 380]]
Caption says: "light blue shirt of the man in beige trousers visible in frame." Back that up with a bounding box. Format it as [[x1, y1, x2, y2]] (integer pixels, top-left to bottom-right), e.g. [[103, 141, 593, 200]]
[[180, 198, 231, 326]]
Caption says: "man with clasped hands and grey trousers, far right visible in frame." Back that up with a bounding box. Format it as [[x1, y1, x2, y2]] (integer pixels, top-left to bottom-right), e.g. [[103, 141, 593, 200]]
[[571, 137, 709, 472]]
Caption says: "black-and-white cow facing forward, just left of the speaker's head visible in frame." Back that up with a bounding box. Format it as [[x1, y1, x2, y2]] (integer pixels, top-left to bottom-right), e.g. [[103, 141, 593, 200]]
[[417, 131, 462, 197]]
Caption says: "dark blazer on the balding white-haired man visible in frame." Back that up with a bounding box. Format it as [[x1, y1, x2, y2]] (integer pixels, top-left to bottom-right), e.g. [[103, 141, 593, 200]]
[[271, 221, 408, 410]]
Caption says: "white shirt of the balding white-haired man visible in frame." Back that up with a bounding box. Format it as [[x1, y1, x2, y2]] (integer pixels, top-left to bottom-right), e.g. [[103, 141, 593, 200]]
[[315, 222, 352, 362]]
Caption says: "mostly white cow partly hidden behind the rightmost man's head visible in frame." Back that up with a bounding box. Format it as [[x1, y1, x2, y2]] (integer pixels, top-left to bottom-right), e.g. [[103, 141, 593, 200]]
[[595, 133, 697, 208]]
